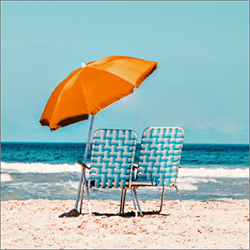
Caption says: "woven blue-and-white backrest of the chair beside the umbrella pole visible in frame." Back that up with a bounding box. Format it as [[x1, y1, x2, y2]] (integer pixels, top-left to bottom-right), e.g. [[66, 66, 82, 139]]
[[88, 129, 137, 188]]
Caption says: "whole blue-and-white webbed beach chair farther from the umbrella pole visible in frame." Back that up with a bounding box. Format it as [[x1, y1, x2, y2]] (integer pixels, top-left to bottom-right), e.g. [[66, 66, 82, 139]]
[[121, 127, 185, 216]]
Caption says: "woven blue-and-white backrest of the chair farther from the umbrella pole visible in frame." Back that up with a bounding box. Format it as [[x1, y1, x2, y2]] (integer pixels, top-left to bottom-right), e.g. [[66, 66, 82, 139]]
[[137, 127, 184, 186]]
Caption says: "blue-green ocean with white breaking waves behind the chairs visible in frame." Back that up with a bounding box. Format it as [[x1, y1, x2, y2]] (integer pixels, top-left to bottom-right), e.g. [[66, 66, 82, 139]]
[[1, 142, 249, 201]]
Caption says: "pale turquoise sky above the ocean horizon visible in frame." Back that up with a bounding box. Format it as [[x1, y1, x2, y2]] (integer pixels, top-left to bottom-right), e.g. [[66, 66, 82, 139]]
[[1, 1, 249, 144]]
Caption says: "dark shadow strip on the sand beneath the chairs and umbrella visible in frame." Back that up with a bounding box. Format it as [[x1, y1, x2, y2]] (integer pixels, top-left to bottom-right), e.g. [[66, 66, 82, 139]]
[[59, 209, 170, 218]]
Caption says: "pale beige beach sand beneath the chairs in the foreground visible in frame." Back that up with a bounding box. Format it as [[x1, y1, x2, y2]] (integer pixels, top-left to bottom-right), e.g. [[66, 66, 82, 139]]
[[1, 200, 249, 249]]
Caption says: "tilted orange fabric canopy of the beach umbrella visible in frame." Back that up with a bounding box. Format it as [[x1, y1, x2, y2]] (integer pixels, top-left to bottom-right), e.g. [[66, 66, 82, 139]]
[[40, 56, 157, 130]]
